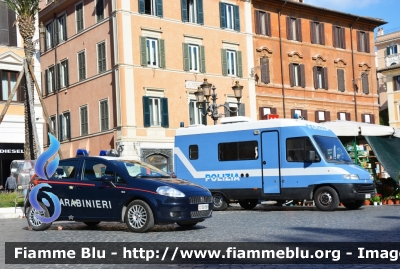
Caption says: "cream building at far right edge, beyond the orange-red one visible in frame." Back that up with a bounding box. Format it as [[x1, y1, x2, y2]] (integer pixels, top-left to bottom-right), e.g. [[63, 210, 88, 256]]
[[375, 28, 400, 128]]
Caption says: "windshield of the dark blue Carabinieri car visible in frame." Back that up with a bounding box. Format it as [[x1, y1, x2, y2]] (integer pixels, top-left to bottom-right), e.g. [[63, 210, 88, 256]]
[[115, 160, 171, 178]]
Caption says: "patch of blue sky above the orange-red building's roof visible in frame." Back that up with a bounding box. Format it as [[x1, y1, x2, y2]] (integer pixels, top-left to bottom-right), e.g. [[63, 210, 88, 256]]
[[304, 0, 400, 33]]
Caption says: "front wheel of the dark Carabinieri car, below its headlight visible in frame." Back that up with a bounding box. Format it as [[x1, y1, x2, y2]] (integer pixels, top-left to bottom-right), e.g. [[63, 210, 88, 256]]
[[125, 200, 154, 233]]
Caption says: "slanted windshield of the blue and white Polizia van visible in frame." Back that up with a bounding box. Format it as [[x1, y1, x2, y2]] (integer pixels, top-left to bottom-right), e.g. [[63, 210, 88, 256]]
[[313, 135, 353, 163]]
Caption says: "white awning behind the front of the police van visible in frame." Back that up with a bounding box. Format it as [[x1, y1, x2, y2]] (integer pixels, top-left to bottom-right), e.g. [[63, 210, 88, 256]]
[[321, 120, 400, 137]]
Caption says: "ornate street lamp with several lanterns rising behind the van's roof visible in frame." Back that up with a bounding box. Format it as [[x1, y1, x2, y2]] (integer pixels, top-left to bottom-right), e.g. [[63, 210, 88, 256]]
[[194, 78, 243, 125]]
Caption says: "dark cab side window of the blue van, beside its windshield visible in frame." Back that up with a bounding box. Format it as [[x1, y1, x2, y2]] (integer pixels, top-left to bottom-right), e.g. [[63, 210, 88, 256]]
[[286, 137, 320, 162]]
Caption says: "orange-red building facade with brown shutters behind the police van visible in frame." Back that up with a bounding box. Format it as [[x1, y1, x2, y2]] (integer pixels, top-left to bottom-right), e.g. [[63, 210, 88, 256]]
[[251, 0, 385, 123]]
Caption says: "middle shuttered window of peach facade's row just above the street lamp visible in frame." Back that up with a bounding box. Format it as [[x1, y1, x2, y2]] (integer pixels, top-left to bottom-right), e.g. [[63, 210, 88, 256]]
[[183, 43, 206, 73]]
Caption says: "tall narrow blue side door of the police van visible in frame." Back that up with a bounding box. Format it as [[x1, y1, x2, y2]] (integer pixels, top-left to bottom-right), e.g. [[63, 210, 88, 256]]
[[261, 131, 281, 194]]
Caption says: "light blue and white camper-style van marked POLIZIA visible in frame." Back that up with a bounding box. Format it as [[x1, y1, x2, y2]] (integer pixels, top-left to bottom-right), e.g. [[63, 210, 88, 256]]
[[174, 117, 375, 211]]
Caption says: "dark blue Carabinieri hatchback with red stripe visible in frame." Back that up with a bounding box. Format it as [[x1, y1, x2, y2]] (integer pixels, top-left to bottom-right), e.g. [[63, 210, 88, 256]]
[[25, 151, 213, 232]]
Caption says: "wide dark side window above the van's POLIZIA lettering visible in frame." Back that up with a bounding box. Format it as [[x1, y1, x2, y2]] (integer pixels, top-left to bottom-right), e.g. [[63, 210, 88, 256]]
[[218, 141, 258, 161]]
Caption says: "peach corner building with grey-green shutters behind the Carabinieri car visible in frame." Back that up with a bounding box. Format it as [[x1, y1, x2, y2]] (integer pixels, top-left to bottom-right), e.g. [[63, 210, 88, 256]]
[[39, 0, 253, 171]]
